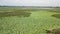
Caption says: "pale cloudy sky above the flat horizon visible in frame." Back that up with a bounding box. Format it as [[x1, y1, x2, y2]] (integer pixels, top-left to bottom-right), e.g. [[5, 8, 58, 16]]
[[0, 0, 60, 6]]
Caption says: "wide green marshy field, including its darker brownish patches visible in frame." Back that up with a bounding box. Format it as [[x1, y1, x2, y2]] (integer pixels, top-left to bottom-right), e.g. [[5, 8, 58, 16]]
[[0, 8, 60, 34]]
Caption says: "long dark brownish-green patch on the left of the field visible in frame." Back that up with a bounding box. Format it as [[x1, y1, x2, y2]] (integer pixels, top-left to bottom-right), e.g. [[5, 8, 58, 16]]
[[0, 11, 31, 17]]
